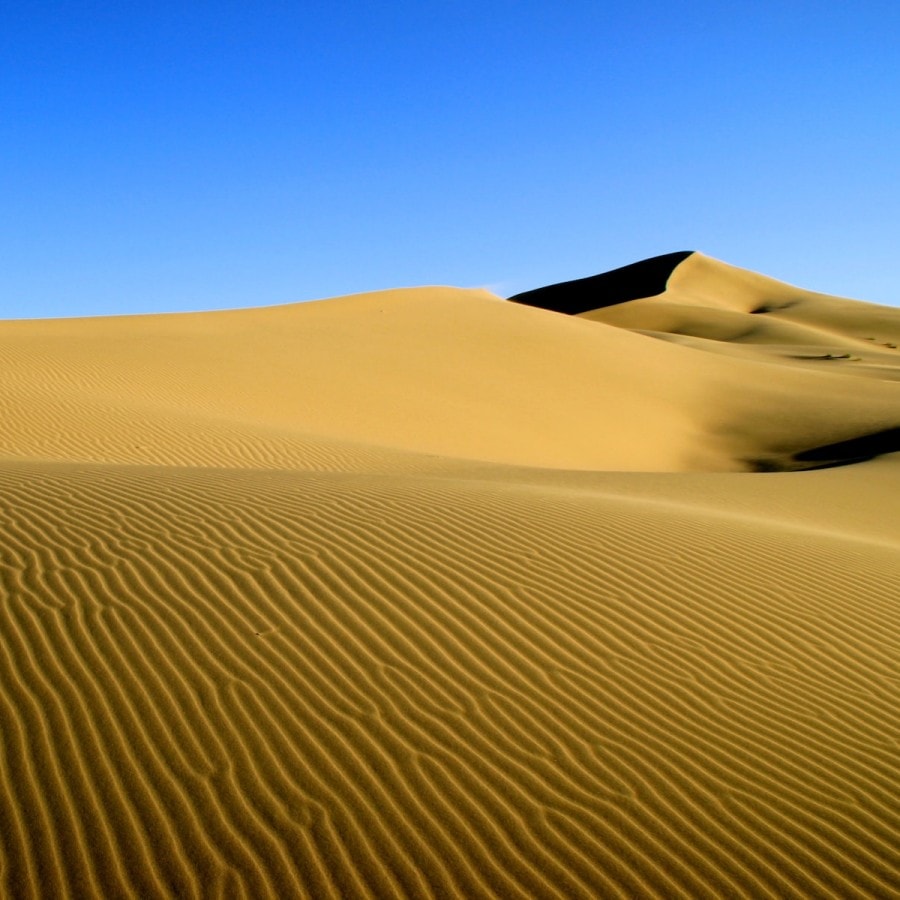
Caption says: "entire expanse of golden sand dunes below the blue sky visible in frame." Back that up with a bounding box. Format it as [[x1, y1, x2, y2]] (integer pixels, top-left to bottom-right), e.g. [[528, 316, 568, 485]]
[[0, 253, 900, 898]]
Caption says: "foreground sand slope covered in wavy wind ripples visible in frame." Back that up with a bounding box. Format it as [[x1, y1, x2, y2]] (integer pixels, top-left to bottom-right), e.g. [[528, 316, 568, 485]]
[[0, 466, 900, 897]]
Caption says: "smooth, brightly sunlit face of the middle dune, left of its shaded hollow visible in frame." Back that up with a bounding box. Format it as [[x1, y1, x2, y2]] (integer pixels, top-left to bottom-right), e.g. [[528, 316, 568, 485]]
[[0, 288, 704, 469]]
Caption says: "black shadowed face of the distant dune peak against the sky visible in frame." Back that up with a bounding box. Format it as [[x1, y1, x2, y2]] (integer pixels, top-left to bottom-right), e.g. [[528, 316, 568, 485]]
[[509, 250, 695, 316]]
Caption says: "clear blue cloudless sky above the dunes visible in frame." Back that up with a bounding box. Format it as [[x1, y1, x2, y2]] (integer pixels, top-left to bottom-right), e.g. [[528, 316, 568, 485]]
[[0, 0, 900, 317]]
